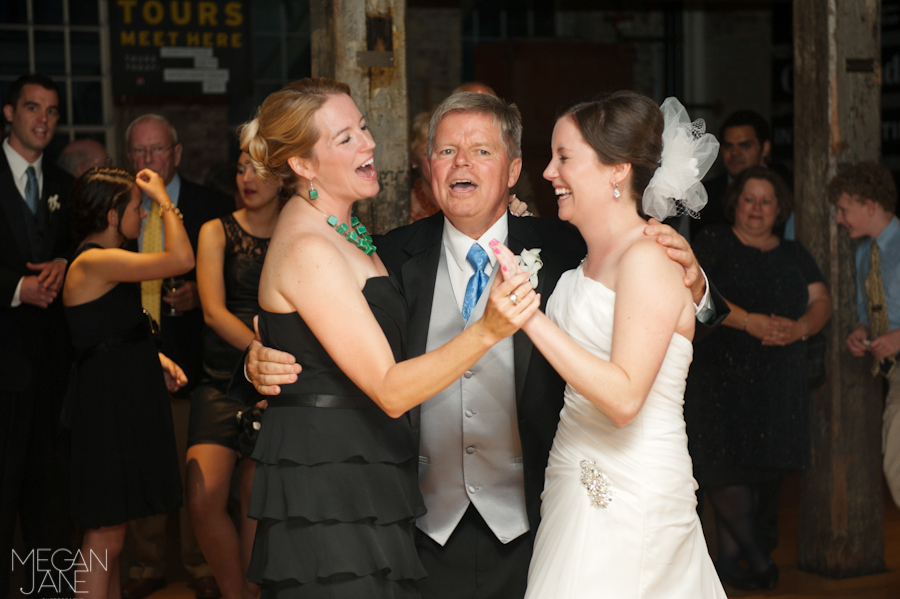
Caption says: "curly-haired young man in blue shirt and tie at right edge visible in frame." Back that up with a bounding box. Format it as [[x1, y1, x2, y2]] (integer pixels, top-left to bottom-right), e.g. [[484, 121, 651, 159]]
[[828, 162, 900, 506]]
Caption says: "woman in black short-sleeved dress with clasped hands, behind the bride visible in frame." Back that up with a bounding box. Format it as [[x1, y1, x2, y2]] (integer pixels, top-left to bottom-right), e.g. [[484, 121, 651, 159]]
[[685, 167, 831, 590]]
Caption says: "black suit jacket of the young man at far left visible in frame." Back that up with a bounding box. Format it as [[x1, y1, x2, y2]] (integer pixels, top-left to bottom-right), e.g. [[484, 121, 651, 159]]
[[0, 152, 74, 393]]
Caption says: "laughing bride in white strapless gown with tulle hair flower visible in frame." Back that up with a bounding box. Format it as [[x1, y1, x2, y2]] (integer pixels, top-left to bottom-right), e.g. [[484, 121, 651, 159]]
[[495, 92, 725, 599]]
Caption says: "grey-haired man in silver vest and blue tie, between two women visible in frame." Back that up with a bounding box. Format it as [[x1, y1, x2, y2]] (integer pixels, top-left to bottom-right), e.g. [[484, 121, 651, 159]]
[[237, 93, 724, 599]]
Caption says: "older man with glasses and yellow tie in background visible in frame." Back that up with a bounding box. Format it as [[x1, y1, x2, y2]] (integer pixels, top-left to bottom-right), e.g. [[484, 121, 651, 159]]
[[122, 114, 234, 599]]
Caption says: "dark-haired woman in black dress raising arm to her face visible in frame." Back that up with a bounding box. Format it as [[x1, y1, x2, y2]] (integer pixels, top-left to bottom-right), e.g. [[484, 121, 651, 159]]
[[63, 168, 194, 599]]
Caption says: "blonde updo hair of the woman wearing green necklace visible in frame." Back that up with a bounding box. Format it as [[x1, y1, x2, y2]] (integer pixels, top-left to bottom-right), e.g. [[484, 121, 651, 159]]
[[237, 77, 350, 194]]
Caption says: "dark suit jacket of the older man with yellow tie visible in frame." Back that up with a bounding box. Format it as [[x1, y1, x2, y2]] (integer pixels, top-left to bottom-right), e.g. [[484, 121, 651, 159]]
[[160, 177, 235, 397]]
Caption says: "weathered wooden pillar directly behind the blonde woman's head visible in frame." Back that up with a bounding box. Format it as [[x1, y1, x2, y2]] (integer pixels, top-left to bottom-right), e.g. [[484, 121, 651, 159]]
[[310, 0, 410, 233]]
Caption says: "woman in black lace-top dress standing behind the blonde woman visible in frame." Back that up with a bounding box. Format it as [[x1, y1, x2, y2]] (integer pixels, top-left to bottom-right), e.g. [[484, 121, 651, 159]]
[[186, 152, 280, 599]]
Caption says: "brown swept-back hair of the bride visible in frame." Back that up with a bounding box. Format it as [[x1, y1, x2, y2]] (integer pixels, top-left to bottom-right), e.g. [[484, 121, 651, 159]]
[[559, 90, 665, 210]]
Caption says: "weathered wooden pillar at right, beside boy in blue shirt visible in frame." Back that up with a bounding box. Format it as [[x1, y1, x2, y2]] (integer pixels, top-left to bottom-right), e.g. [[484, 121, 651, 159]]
[[793, 0, 884, 578]]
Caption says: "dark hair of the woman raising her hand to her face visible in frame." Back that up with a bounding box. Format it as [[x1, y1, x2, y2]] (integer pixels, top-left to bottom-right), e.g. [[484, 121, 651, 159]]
[[70, 166, 136, 243]]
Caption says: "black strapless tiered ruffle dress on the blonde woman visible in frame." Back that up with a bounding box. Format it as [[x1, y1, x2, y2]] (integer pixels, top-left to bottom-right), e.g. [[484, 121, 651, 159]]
[[248, 277, 425, 599]]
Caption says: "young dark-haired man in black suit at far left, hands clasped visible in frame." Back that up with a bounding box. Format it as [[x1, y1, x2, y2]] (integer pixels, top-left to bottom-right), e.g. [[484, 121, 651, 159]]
[[0, 75, 73, 597]]
